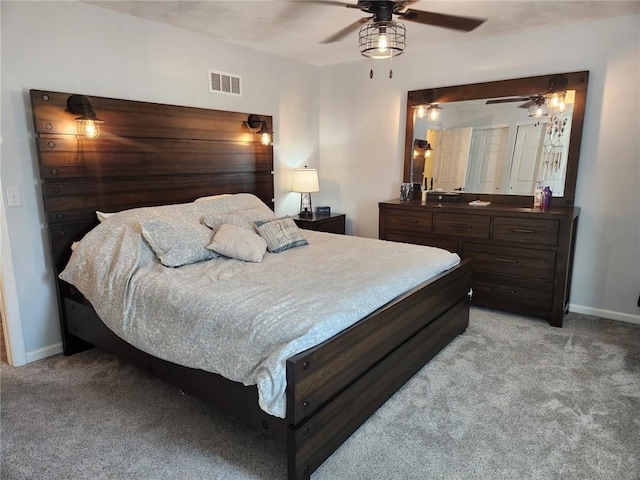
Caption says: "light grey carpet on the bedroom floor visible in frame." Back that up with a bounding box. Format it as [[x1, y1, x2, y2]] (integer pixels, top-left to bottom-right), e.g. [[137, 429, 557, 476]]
[[0, 308, 640, 480]]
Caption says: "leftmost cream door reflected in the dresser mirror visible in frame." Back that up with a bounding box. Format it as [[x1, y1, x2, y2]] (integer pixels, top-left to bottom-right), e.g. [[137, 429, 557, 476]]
[[434, 128, 472, 191]]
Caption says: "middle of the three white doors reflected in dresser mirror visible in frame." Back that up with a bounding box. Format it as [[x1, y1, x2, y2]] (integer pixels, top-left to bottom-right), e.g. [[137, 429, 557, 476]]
[[466, 127, 509, 193]]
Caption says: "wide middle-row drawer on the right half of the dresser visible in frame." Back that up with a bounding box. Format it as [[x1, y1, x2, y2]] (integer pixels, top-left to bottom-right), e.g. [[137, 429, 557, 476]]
[[462, 243, 556, 281]]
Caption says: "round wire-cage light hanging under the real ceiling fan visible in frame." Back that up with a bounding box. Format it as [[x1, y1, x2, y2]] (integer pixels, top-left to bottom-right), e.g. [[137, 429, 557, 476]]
[[359, 20, 406, 59]]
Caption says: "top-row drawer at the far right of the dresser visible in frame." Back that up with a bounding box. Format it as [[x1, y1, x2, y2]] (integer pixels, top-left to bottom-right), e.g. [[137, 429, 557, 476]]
[[491, 217, 559, 246]]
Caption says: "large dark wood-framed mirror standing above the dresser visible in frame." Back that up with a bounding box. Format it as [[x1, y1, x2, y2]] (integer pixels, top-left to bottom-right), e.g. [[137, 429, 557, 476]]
[[404, 72, 589, 206]]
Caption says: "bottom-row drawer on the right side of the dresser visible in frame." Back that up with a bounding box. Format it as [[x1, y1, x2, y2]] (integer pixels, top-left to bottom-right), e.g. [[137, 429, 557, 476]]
[[471, 272, 553, 317]]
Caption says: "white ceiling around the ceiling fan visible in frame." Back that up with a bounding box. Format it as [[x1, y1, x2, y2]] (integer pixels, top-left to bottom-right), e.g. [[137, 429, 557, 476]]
[[84, 0, 640, 66]]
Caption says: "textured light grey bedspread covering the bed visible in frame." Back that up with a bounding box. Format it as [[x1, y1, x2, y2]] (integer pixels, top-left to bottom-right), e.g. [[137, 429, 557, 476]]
[[60, 196, 460, 418]]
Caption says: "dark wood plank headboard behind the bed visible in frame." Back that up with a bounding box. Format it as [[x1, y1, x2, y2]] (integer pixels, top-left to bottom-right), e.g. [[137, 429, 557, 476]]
[[30, 90, 274, 276]]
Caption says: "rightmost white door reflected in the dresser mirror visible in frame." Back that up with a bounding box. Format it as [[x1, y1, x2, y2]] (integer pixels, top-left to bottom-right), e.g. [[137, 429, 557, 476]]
[[509, 122, 547, 195]]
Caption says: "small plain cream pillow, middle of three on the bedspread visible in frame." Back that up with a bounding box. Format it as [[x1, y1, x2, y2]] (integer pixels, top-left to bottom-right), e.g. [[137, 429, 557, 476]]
[[207, 223, 267, 263]]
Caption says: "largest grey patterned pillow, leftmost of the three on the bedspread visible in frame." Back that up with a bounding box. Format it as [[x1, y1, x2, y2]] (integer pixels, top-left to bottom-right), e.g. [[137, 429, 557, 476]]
[[140, 220, 218, 267]]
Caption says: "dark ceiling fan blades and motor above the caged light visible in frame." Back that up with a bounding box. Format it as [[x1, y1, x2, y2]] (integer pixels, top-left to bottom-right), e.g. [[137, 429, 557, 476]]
[[313, 0, 486, 43]]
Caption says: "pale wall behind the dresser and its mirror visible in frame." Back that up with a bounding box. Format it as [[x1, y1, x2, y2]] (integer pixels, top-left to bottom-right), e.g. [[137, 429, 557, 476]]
[[319, 15, 640, 323]]
